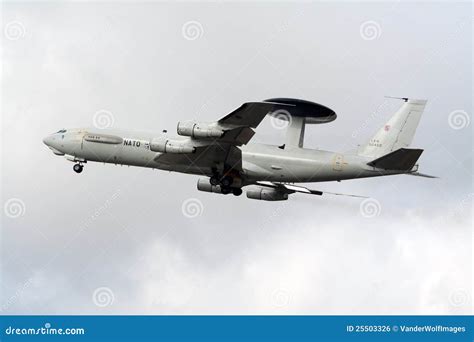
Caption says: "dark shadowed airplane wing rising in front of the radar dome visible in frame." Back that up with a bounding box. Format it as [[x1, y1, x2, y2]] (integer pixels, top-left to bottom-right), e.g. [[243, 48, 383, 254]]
[[155, 102, 294, 175]]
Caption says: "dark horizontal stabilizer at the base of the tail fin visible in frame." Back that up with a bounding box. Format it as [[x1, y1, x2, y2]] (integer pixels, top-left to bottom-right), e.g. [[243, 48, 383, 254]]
[[367, 148, 423, 171]]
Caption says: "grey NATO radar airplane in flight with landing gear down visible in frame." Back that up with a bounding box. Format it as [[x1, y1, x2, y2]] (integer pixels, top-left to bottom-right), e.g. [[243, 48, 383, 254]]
[[43, 98, 435, 201]]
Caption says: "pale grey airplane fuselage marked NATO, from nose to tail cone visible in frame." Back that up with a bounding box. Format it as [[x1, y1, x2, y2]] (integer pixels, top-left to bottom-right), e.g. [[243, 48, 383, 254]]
[[44, 128, 405, 185]]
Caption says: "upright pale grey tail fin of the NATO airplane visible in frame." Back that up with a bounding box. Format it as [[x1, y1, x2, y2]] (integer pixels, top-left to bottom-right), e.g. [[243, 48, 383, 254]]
[[359, 99, 427, 157]]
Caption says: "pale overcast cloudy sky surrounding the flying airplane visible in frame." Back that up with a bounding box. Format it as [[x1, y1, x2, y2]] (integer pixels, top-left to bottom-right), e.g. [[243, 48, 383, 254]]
[[0, 2, 473, 314]]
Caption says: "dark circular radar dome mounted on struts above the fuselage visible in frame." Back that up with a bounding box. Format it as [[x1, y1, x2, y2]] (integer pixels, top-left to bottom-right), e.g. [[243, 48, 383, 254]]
[[264, 98, 337, 124]]
